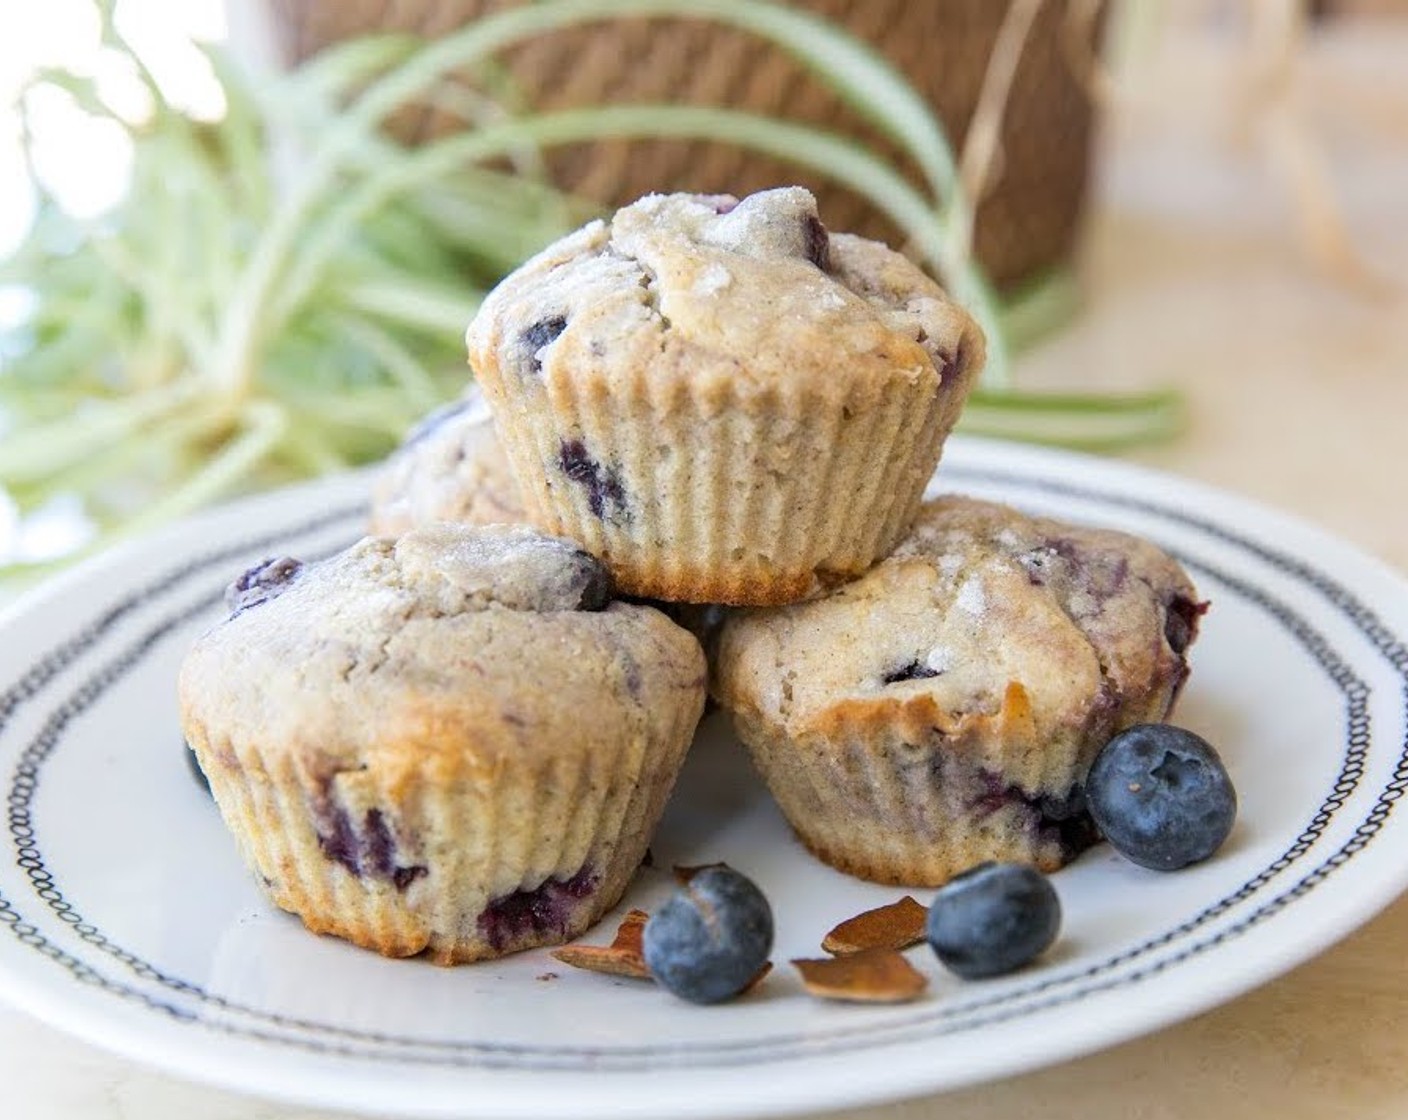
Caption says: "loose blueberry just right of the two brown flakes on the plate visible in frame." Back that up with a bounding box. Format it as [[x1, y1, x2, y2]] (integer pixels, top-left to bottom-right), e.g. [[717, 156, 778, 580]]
[[925, 864, 1060, 981]]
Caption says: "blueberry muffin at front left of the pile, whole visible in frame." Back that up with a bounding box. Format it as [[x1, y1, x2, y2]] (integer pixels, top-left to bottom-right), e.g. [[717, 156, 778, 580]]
[[180, 524, 705, 964]]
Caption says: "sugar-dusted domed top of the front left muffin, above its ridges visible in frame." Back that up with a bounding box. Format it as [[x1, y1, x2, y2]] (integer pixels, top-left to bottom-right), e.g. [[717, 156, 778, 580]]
[[180, 523, 705, 780]]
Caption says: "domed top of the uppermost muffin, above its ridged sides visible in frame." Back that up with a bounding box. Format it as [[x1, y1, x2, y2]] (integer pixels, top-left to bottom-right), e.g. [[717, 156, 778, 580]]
[[467, 187, 983, 407]]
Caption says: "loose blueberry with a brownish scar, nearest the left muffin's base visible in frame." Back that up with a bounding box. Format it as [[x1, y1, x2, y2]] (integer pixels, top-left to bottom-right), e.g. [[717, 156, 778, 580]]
[[643, 866, 773, 1003]]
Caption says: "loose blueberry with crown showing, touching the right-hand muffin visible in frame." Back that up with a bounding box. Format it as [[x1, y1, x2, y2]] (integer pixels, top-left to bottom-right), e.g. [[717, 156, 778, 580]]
[[1086, 723, 1236, 871]]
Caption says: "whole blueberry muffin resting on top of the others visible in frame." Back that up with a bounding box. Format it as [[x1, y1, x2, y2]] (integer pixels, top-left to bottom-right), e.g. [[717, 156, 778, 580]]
[[467, 187, 984, 604]]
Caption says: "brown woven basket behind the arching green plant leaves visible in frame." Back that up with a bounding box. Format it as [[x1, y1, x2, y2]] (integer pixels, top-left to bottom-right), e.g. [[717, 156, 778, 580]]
[[270, 0, 1098, 287]]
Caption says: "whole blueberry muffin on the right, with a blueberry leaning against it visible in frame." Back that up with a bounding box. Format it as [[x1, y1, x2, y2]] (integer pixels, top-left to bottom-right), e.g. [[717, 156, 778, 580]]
[[714, 497, 1205, 886]]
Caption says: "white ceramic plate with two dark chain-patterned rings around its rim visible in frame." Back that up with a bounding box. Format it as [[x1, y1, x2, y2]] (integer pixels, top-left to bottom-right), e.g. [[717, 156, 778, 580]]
[[0, 440, 1408, 1120]]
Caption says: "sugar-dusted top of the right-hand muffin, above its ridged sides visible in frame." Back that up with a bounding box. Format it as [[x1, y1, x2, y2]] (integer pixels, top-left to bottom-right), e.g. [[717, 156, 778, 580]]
[[717, 497, 1204, 744]]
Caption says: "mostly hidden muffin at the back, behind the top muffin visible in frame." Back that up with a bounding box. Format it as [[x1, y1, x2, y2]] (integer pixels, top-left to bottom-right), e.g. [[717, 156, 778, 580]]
[[370, 387, 528, 537]]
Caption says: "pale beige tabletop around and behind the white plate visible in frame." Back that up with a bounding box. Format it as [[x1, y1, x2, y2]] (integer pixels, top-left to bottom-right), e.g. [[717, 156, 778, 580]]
[[0, 10, 1408, 1120]]
